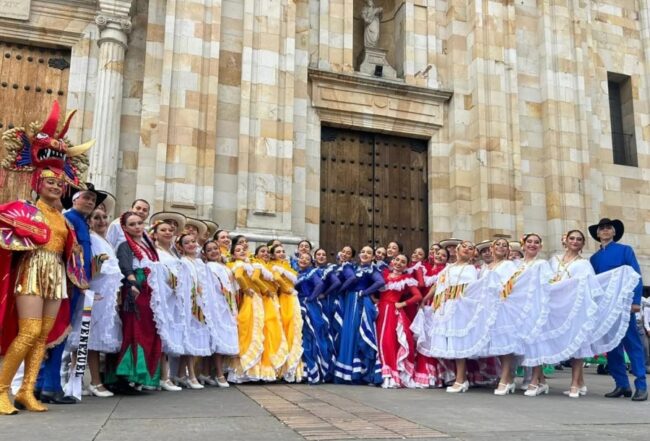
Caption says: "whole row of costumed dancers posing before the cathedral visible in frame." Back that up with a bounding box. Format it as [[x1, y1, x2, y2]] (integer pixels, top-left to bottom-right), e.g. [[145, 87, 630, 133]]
[[0, 105, 647, 415]]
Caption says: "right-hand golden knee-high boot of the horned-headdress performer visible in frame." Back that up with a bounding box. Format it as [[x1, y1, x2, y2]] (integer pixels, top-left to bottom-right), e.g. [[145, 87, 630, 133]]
[[14, 316, 55, 412]]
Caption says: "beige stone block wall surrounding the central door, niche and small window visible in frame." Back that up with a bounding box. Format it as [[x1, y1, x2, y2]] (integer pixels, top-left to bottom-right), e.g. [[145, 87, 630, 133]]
[[0, 0, 650, 271]]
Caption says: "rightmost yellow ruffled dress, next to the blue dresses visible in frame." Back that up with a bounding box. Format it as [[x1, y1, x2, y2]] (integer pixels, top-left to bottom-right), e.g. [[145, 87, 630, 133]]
[[269, 260, 304, 383]]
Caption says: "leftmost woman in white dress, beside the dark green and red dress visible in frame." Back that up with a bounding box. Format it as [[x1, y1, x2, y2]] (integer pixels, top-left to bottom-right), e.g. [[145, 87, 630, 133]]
[[88, 208, 122, 398]]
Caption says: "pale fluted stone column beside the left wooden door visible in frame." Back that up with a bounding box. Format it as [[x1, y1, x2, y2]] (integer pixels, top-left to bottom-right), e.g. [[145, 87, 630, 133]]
[[88, 1, 131, 193]]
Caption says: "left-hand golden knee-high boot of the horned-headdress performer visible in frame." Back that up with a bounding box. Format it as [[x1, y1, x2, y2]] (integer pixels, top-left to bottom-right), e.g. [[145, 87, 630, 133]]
[[0, 318, 42, 415]]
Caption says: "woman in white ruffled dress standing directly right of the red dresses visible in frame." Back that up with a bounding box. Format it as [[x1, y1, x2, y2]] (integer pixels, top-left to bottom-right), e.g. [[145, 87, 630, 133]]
[[411, 241, 499, 393]]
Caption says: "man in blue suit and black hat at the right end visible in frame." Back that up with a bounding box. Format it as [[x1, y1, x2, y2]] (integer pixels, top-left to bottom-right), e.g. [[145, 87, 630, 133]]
[[589, 218, 648, 401]]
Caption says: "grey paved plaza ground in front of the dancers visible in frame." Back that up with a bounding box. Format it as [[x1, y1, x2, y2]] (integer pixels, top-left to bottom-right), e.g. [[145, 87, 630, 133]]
[[0, 368, 650, 441]]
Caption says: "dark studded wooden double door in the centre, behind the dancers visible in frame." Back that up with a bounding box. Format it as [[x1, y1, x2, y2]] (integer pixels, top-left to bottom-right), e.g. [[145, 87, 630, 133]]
[[320, 127, 428, 256]]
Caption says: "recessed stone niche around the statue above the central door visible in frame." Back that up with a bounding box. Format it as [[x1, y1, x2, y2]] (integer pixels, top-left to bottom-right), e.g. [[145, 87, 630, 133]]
[[353, 0, 406, 78]]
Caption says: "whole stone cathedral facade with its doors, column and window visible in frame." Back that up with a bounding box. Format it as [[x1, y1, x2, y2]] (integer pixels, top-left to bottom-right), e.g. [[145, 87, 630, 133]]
[[0, 0, 650, 276]]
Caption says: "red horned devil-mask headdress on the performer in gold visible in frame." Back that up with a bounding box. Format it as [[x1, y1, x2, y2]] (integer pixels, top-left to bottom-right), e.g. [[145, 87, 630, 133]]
[[0, 101, 95, 199]]
